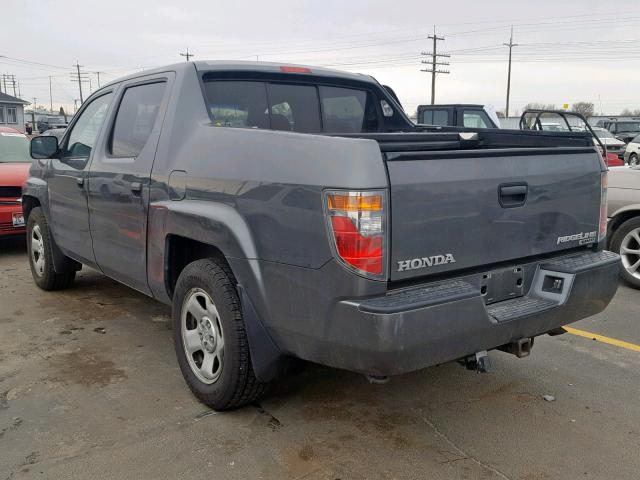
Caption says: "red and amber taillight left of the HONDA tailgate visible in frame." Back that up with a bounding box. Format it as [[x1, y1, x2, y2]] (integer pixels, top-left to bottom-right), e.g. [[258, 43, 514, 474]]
[[325, 190, 387, 279]]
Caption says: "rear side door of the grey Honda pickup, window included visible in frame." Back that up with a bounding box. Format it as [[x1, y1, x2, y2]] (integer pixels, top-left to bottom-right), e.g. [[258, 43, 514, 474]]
[[89, 76, 169, 293]]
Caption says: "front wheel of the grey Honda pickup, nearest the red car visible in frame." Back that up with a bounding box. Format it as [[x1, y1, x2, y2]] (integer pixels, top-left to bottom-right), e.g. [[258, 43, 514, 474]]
[[27, 207, 76, 291]]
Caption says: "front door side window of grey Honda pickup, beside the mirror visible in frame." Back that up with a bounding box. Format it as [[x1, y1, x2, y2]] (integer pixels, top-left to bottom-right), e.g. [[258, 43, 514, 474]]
[[62, 93, 113, 160]]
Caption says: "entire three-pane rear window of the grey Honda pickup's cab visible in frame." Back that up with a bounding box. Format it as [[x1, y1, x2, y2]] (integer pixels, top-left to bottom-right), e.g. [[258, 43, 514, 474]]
[[204, 80, 379, 133]]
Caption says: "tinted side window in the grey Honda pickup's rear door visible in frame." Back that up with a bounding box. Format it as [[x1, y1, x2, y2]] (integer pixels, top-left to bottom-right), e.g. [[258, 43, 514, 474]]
[[109, 82, 166, 158]]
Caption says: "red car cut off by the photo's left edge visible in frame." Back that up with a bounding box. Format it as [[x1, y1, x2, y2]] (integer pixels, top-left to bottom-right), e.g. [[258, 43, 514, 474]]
[[0, 127, 31, 238]]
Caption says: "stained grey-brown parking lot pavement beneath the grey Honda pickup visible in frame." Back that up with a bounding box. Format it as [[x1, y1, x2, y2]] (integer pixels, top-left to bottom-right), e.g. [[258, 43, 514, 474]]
[[0, 237, 640, 480]]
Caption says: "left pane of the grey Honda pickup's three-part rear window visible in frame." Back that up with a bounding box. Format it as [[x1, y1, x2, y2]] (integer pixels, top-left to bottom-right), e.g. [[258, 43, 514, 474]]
[[204, 81, 269, 128]]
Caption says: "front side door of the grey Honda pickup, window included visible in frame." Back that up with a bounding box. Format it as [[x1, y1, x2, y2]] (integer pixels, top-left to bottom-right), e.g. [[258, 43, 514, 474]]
[[46, 92, 113, 266]]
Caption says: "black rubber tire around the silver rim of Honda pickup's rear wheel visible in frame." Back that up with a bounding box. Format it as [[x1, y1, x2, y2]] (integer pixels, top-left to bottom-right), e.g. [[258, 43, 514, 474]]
[[173, 258, 268, 410]]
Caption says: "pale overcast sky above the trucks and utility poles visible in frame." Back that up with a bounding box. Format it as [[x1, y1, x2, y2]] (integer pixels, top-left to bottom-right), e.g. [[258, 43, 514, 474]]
[[0, 0, 640, 114]]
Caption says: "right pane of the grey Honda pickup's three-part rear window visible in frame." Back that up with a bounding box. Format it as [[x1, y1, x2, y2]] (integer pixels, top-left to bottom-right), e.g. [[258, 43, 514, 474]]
[[320, 86, 378, 133]]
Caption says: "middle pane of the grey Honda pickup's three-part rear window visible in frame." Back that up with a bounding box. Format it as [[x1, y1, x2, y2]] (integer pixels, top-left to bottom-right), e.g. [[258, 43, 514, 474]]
[[269, 83, 322, 133]]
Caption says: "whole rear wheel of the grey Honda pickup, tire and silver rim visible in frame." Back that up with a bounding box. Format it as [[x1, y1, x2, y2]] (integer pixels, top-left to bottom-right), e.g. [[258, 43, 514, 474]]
[[173, 259, 267, 410]]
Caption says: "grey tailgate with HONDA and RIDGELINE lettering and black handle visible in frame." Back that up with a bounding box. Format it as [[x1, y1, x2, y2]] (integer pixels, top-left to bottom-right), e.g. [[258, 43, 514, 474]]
[[385, 147, 602, 280]]
